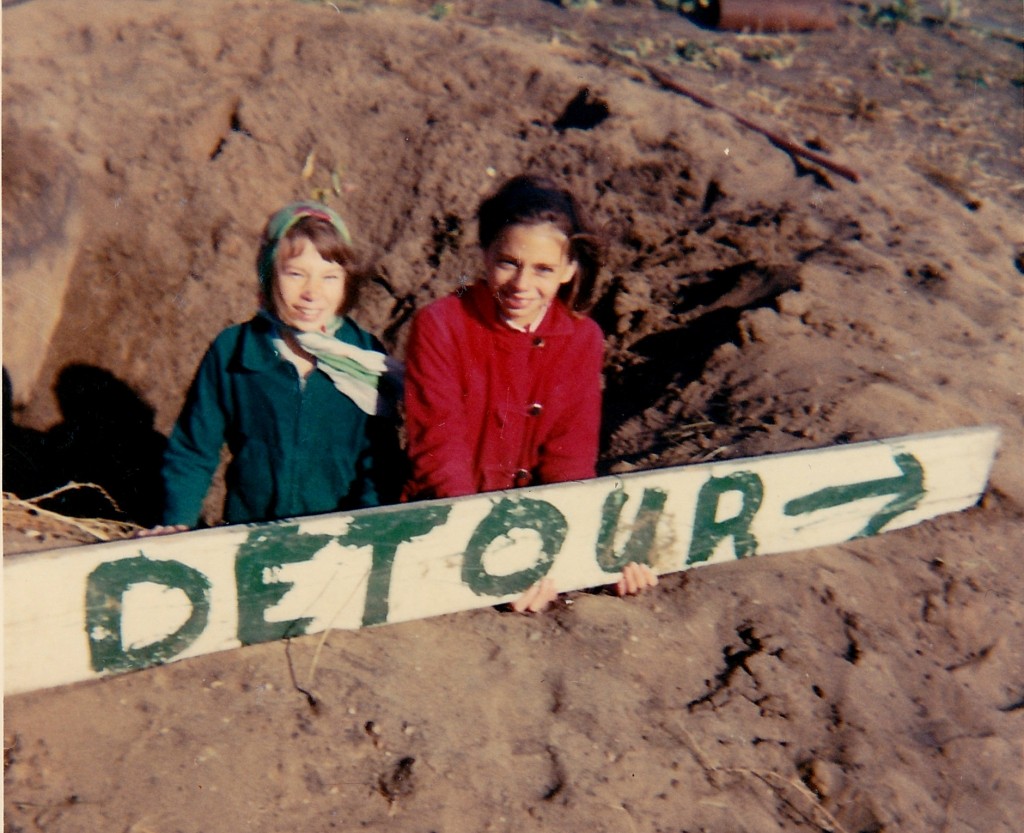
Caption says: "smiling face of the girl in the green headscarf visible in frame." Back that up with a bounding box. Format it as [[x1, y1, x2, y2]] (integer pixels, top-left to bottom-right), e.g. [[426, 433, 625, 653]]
[[273, 238, 345, 333]]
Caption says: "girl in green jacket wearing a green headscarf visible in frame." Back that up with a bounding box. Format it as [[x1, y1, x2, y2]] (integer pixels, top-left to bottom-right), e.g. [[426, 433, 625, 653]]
[[152, 202, 401, 533]]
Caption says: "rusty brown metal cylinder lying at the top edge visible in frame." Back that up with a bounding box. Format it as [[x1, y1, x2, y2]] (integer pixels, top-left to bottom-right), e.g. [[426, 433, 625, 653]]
[[688, 0, 837, 33]]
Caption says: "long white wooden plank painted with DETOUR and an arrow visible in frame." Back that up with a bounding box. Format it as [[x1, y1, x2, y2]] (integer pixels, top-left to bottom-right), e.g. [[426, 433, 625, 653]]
[[4, 427, 998, 694]]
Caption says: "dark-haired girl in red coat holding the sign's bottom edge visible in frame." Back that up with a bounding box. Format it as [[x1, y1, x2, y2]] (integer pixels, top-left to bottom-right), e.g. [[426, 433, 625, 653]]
[[406, 176, 657, 611]]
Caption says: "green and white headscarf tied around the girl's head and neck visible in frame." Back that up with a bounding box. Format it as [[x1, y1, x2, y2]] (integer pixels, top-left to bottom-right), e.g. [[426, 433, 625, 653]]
[[256, 200, 404, 417]]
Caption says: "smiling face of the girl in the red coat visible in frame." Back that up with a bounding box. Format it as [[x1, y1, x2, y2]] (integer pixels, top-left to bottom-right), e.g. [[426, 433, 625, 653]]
[[484, 222, 577, 327]]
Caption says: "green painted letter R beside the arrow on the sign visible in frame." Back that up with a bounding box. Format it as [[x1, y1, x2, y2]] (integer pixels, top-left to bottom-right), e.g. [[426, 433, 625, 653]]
[[686, 471, 765, 565]]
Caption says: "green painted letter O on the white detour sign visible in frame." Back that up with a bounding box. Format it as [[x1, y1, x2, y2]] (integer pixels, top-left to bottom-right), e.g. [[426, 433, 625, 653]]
[[462, 498, 568, 596]]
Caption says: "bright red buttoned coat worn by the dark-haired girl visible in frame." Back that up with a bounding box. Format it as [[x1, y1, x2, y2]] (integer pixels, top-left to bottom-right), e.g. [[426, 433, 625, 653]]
[[406, 282, 604, 498]]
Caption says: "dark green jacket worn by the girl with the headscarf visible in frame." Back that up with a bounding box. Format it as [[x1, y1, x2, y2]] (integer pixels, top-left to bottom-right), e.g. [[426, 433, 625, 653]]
[[163, 318, 402, 527]]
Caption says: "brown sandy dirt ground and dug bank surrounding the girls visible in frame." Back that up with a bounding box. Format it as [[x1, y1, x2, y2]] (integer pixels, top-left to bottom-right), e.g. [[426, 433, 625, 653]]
[[3, 0, 1024, 833]]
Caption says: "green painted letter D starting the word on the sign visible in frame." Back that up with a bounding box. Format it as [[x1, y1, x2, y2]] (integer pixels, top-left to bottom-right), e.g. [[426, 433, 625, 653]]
[[85, 554, 210, 671]]
